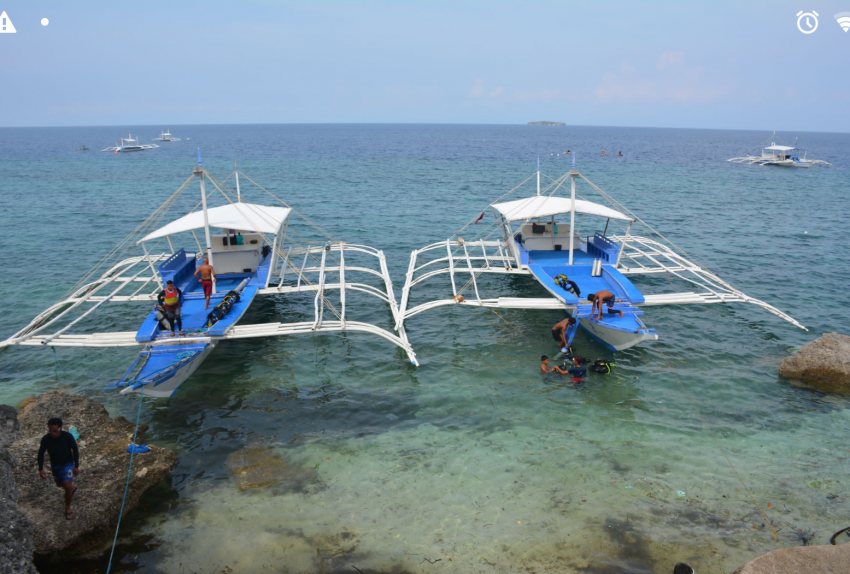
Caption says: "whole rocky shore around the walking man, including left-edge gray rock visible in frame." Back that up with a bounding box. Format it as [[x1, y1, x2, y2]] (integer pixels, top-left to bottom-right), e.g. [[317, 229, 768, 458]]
[[0, 391, 176, 574]]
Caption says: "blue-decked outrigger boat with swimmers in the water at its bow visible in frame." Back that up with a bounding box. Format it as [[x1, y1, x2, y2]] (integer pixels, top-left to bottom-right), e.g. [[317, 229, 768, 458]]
[[397, 156, 805, 356]]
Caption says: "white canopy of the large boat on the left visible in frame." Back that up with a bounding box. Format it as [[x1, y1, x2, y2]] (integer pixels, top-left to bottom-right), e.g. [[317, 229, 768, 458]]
[[137, 202, 292, 243]]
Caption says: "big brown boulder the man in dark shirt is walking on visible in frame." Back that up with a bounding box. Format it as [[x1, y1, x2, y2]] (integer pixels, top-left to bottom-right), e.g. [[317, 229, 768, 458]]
[[10, 391, 176, 557]]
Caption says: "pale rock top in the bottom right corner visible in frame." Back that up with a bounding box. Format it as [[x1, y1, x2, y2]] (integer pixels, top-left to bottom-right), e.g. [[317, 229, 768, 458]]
[[734, 544, 850, 574]]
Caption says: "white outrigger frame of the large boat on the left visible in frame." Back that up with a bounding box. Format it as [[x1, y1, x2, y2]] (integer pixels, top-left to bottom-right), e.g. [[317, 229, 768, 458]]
[[0, 170, 419, 372]]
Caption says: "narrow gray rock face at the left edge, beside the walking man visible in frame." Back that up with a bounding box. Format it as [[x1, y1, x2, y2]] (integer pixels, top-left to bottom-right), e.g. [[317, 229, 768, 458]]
[[0, 405, 36, 574]]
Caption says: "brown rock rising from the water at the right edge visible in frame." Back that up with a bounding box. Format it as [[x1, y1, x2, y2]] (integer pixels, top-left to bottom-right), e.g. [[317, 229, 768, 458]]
[[779, 333, 850, 393]]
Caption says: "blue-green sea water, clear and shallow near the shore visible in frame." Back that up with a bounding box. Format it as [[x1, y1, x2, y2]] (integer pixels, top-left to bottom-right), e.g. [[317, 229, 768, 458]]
[[0, 125, 850, 574]]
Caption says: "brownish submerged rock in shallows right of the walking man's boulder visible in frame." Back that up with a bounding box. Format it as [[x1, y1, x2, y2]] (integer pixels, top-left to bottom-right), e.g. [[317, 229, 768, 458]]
[[225, 444, 317, 491]]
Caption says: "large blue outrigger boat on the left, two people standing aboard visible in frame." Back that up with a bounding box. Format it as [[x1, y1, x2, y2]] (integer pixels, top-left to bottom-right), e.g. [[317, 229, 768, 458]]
[[0, 158, 417, 397]]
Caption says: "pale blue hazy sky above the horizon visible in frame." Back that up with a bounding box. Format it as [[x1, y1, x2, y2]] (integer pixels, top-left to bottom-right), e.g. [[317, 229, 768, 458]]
[[0, 0, 850, 132]]
